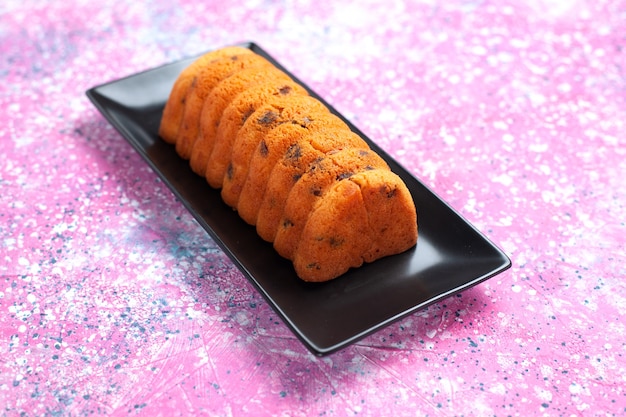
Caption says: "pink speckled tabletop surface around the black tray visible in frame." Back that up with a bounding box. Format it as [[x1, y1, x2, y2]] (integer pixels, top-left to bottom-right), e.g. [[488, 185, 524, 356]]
[[0, 0, 626, 416]]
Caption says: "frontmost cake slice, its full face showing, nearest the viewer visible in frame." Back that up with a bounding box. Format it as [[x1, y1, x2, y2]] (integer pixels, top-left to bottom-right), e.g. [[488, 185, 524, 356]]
[[293, 169, 417, 282]]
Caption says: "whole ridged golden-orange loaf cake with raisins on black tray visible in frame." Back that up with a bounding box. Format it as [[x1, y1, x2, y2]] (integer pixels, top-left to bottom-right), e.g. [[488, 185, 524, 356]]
[[159, 46, 418, 282]]
